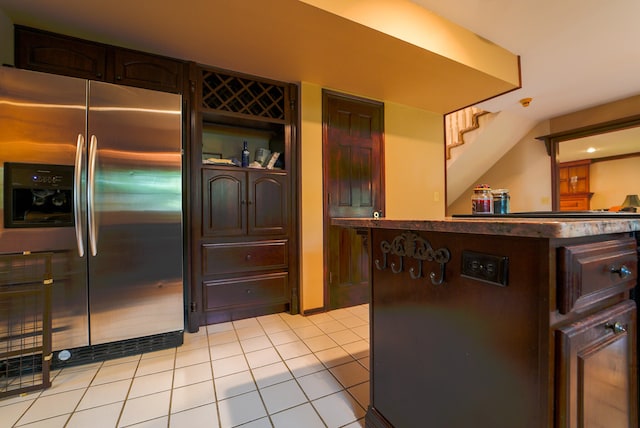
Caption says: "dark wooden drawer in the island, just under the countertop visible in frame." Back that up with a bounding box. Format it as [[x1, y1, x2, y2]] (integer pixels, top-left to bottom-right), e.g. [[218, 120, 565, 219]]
[[557, 238, 638, 314]]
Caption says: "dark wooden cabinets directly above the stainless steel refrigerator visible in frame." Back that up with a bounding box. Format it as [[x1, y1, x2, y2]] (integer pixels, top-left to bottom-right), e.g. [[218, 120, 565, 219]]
[[15, 25, 186, 93]]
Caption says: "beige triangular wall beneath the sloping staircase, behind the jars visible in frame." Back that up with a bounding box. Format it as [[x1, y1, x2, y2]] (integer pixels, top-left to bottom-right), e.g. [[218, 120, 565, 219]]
[[449, 121, 551, 215]]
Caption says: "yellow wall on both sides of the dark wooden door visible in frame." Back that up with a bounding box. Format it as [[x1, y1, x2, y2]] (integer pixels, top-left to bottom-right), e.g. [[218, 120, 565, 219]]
[[300, 82, 445, 312]]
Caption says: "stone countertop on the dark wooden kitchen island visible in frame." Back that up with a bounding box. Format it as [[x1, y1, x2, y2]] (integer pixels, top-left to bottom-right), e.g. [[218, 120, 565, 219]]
[[331, 213, 640, 238]]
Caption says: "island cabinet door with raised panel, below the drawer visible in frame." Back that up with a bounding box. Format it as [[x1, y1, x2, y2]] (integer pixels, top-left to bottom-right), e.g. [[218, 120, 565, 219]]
[[556, 301, 638, 428]]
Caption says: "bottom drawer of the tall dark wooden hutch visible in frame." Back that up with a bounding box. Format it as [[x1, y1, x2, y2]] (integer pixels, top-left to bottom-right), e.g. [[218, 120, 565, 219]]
[[204, 272, 289, 310]]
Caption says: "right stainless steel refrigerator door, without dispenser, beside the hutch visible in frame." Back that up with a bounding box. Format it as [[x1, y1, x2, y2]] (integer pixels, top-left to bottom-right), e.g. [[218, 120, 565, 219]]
[[87, 82, 184, 345]]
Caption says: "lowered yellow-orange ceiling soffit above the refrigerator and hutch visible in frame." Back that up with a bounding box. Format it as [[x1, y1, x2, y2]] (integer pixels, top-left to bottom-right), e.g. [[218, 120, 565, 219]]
[[0, 0, 520, 113]]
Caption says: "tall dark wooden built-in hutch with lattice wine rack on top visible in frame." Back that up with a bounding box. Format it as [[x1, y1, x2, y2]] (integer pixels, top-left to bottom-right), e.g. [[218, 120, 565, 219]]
[[190, 64, 298, 329]]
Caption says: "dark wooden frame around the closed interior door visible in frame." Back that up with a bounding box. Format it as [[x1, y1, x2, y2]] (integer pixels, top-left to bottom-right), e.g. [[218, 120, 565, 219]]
[[322, 88, 386, 311]]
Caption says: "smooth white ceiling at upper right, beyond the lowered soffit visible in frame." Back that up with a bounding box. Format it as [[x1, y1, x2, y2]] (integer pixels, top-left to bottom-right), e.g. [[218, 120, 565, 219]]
[[412, 0, 640, 121]]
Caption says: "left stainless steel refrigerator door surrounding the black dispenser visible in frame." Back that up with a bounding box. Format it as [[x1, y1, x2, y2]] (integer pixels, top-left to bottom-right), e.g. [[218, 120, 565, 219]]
[[0, 67, 89, 350]]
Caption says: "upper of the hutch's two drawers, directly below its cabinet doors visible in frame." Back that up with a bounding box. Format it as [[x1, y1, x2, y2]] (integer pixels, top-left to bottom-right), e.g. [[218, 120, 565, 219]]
[[202, 239, 289, 275]]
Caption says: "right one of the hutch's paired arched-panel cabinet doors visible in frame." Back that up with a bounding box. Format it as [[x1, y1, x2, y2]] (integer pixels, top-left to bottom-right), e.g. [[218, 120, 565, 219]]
[[248, 172, 289, 235]]
